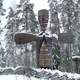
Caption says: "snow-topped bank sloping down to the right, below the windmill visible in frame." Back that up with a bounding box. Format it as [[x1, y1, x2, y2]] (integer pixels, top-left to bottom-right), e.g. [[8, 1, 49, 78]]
[[33, 69, 80, 80]]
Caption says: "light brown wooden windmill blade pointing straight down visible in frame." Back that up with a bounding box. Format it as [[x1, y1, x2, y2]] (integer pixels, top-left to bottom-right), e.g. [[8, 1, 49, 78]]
[[39, 42, 51, 68]]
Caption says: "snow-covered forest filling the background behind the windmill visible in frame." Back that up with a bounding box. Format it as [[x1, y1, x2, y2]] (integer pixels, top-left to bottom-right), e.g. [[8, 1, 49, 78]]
[[0, 0, 80, 73]]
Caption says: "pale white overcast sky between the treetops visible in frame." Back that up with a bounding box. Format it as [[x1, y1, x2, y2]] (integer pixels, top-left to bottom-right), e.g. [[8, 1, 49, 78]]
[[4, 0, 49, 14]]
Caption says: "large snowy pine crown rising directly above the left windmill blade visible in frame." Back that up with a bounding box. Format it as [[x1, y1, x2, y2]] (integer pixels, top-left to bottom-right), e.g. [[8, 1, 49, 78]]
[[17, 1, 38, 32]]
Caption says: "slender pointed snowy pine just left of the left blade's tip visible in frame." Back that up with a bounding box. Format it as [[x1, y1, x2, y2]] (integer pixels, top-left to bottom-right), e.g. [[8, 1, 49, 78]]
[[5, 7, 17, 67]]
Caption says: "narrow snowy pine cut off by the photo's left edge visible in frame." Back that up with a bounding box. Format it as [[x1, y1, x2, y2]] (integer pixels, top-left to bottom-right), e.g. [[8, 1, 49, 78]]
[[0, 0, 5, 67]]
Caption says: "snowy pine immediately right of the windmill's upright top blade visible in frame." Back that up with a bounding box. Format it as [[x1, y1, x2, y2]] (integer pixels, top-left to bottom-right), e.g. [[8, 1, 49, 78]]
[[48, 0, 60, 34]]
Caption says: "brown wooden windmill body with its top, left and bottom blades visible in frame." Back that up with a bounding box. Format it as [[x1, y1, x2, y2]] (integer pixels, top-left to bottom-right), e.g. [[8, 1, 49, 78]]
[[15, 9, 56, 68]]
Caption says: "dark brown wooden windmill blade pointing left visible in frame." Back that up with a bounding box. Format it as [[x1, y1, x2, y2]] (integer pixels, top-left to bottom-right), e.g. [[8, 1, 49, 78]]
[[15, 33, 38, 44]]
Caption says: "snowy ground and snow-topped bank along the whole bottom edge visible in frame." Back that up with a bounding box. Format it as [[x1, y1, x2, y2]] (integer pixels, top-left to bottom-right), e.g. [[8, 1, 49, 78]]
[[0, 67, 80, 80]]
